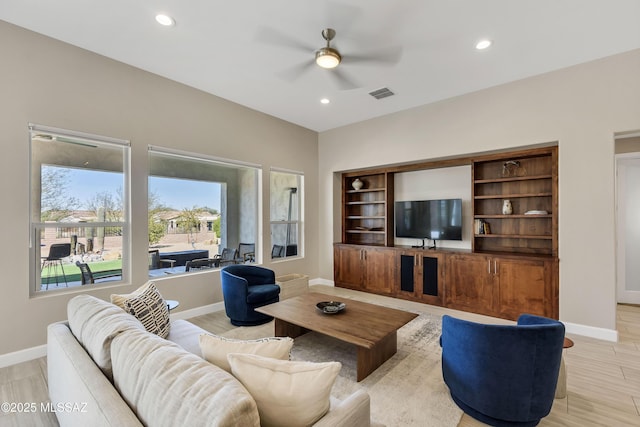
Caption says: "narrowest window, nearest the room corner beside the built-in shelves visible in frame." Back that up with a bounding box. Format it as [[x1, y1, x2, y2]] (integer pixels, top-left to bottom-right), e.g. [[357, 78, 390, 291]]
[[270, 169, 304, 259]]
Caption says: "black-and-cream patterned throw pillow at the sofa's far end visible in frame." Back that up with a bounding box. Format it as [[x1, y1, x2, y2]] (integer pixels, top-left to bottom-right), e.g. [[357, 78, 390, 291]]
[[111, 282, 170, 338]]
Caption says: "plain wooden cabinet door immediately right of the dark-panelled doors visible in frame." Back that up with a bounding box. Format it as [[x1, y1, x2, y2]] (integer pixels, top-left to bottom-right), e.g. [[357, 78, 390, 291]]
[[446, 255, 496, 315]]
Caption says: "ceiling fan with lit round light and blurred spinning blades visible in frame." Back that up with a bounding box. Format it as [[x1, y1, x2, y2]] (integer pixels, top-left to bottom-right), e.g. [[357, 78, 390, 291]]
[[259, 28, 402, 90]]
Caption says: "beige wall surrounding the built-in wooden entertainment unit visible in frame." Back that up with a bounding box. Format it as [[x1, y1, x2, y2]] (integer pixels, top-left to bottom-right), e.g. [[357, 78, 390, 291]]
[[319, 50, 640, 334]]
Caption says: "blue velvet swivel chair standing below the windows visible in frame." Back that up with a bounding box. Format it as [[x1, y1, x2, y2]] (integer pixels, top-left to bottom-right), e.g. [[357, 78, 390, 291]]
[[220, 264, 280, 326]]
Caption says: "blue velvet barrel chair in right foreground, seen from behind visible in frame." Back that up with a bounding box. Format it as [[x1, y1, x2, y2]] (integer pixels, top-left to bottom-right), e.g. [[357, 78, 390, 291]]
[[440, 314, 564, 426]]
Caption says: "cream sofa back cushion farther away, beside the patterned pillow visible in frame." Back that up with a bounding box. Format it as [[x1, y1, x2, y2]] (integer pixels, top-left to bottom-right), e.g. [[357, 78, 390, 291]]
[[67, 295, 144, 380]]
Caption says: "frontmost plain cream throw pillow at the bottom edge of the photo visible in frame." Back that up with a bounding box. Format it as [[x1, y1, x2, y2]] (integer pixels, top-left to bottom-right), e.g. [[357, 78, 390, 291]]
[[227, 353, 342, 427]]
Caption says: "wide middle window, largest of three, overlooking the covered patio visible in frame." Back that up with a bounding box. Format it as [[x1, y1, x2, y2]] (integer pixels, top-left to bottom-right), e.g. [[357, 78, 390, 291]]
[[149, 147, 260, 277]]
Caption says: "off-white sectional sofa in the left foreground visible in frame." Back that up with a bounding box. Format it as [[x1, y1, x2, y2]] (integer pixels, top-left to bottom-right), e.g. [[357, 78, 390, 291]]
[[47, 295, 371, 427]]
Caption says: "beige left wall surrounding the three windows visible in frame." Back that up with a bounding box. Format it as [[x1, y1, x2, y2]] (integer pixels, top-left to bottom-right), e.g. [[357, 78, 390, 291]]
[[0, 21, 318, 356]]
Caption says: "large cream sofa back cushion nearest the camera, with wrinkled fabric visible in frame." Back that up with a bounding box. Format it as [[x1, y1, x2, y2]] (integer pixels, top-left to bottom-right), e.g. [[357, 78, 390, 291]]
[[111, 330, 260, 427]]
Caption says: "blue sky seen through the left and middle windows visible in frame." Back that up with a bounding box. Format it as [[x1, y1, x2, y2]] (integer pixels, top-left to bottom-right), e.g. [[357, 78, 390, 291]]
[[66, 169, 220, 211]]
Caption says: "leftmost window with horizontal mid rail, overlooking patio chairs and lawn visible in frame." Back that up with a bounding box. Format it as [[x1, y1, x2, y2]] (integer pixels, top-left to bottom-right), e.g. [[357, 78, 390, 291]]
[[29, 125, 130, 295]]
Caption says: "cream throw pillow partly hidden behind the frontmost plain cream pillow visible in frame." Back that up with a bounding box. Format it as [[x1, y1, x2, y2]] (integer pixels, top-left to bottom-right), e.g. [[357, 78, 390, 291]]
[[200, 334, 293, 372]]
